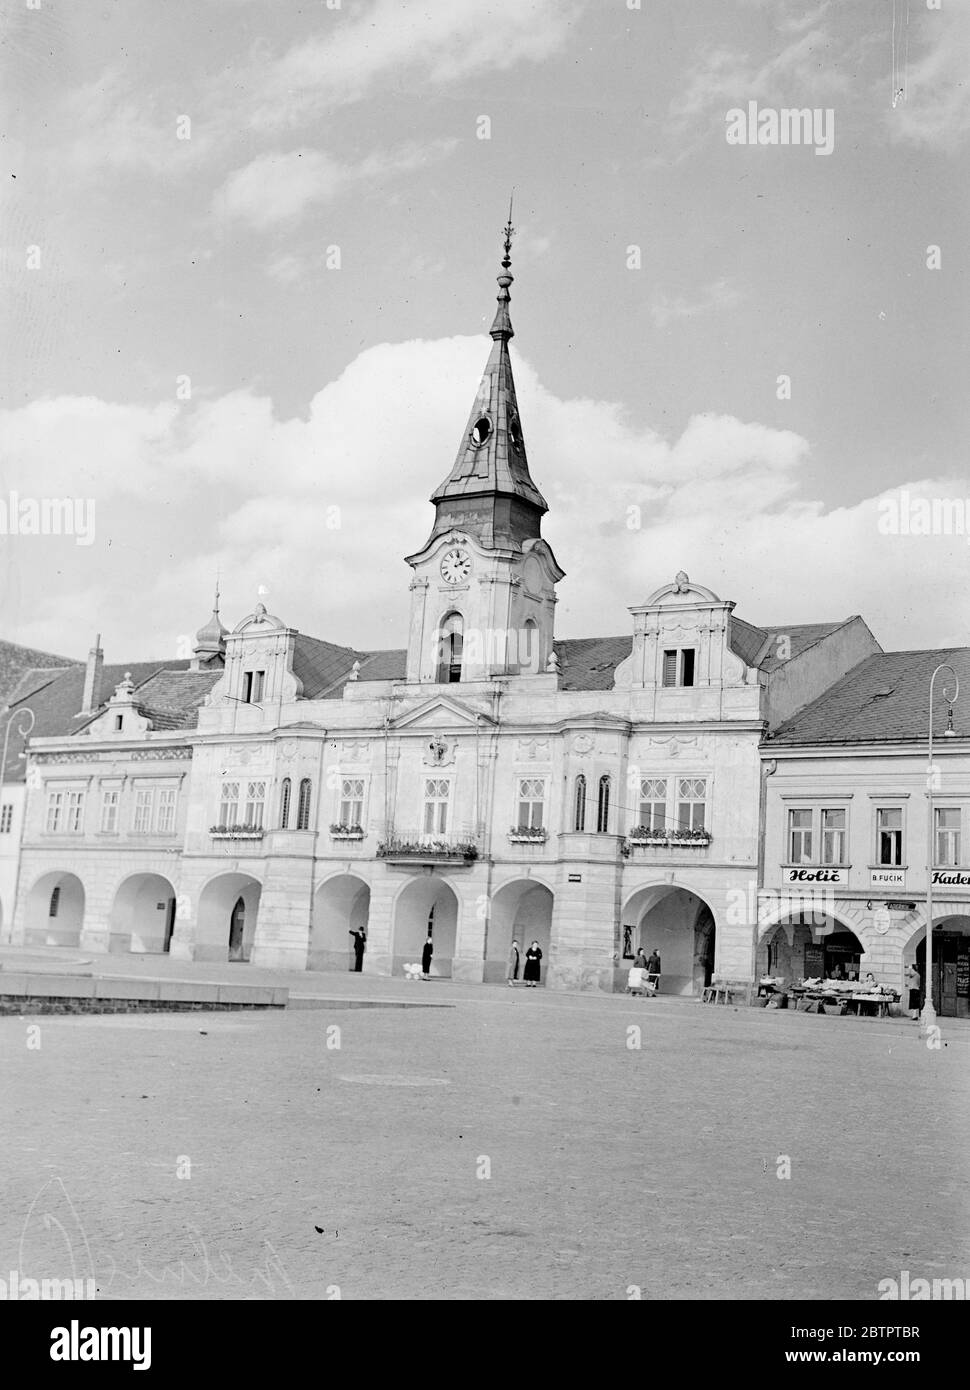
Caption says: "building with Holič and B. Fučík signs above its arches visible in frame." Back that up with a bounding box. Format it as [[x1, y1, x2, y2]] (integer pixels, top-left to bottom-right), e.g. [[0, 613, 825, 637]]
[[757, 648, 970, 1017]]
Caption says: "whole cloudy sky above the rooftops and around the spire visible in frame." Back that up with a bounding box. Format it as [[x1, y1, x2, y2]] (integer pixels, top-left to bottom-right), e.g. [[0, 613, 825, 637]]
[[0, 0, 970, 662]]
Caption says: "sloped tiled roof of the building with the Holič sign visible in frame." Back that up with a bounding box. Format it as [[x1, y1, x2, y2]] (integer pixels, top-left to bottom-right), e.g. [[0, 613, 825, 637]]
[[764, 646, 970, 745]]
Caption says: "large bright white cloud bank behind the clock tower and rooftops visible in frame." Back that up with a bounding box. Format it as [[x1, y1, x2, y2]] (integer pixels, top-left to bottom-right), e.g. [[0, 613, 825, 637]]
[[0, 338, 967, 660]]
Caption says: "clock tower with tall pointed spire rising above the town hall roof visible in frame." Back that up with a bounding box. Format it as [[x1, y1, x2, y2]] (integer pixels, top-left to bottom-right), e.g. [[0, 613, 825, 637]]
[[407, 221, 564, 684]]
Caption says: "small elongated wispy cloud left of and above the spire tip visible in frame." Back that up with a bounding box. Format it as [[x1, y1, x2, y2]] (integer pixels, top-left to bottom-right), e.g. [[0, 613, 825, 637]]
[[213, 139, 457, 227]]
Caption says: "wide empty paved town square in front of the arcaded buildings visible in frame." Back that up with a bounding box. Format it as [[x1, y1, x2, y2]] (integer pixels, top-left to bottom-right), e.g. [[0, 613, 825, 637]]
[[0, 952, 970, 1300]]
